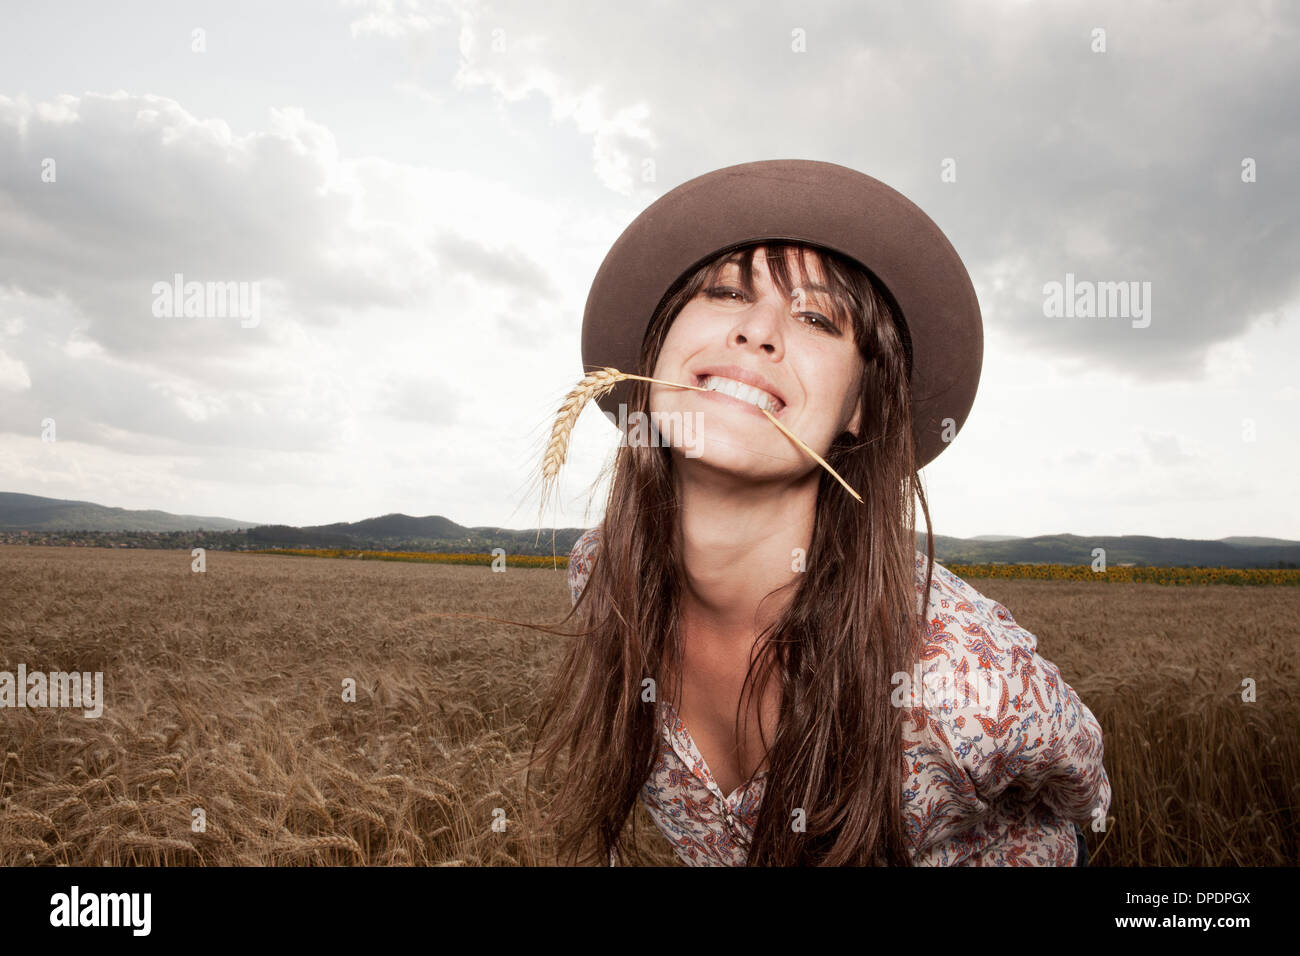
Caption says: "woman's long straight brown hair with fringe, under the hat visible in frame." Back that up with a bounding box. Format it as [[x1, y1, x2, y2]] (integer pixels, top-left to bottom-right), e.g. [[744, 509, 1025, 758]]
[[525, 241, 933, 866]]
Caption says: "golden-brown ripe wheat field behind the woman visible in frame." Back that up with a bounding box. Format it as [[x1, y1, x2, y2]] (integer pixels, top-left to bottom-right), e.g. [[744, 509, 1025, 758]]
[[0, 546, 1300, 866]]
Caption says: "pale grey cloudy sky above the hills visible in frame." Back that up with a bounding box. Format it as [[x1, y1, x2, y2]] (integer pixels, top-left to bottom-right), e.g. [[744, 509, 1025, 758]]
[[0, 0, 1300, 538]]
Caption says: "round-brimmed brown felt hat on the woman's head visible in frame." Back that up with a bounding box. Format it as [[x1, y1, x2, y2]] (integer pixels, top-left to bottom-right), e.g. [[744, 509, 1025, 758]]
[[582, 160, 984, 468]]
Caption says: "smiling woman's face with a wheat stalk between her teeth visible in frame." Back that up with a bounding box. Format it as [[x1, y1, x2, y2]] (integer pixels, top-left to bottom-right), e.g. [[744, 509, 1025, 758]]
[[650, 248, 863, 479]]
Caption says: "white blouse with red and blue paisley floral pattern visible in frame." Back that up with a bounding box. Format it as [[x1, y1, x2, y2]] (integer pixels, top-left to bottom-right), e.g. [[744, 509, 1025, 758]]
[[568, 527, 1110, 866]]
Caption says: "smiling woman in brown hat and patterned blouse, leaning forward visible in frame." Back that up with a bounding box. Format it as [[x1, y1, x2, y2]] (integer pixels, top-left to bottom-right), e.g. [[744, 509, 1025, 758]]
[[534, 160, 1110, 865]]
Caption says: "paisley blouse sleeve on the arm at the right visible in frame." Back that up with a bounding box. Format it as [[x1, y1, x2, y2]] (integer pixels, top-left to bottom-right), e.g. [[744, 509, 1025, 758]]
[[932, 564, 1110, 823]]
